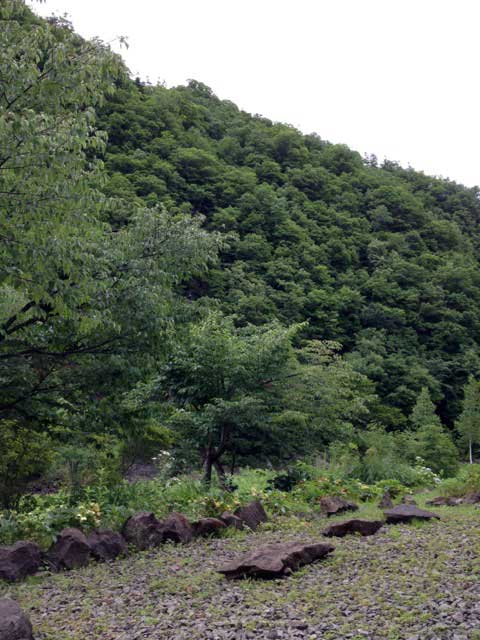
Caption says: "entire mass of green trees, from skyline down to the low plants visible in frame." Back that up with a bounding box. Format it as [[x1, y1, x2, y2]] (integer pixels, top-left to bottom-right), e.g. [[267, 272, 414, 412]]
[[0, 0, 480, 505]]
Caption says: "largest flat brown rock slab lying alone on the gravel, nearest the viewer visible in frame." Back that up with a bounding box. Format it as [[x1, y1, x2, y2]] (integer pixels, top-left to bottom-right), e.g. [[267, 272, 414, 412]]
[[219, 542, 335, 578]]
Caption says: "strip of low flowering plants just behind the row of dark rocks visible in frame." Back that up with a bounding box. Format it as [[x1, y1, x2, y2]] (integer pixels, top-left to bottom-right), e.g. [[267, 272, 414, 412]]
[[0, 463, 431, 547]]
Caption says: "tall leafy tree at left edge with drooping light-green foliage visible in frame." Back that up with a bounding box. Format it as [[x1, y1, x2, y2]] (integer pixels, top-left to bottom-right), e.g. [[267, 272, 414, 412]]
[[0, 0, 218, 504]]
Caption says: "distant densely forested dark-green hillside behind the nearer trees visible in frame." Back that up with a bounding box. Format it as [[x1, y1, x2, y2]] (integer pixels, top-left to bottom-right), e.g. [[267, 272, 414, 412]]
[[100, 76, 480, 428]]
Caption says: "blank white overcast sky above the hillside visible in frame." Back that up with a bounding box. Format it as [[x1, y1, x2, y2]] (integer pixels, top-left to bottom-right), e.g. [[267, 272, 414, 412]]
[[30, 0, 480, 186]]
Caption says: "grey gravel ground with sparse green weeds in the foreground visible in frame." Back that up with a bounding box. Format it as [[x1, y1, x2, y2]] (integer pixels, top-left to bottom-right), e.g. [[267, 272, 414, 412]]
[[0, 506, 480, 640]]
